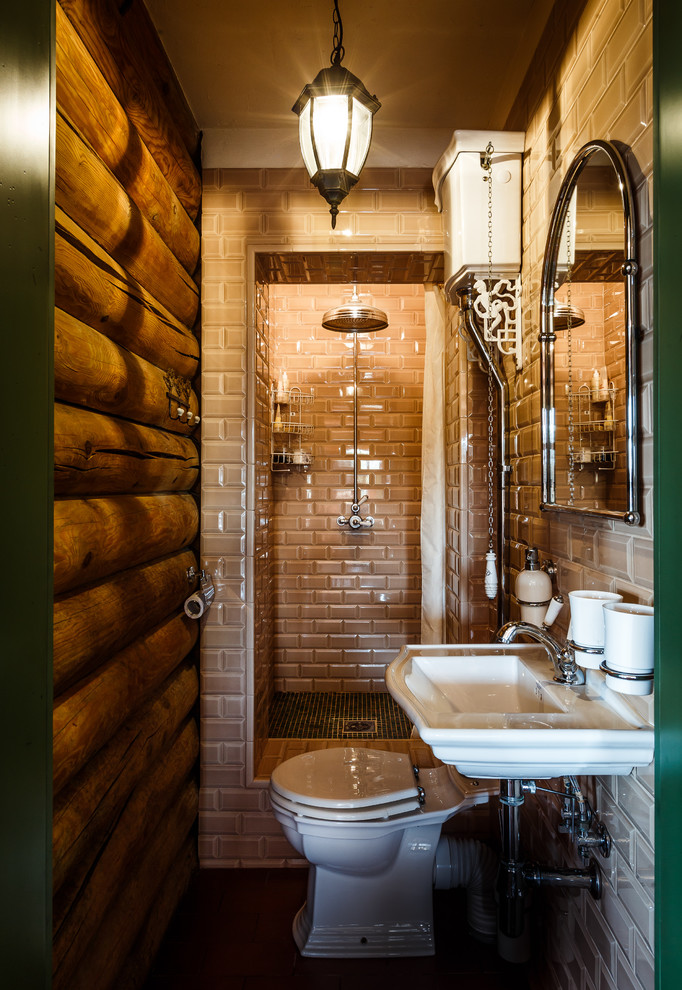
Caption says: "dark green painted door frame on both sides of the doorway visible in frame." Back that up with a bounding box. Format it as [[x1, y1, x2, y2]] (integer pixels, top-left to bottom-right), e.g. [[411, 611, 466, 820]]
[[0, 0, 682, 990]]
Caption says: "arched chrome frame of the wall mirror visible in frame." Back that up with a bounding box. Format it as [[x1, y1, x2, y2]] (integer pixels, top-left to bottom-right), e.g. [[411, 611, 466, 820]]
[[538, 141, 640, 526]]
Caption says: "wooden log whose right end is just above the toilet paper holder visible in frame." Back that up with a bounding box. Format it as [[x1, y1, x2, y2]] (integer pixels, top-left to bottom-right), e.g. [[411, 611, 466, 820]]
[[54, 495, 199, 594]]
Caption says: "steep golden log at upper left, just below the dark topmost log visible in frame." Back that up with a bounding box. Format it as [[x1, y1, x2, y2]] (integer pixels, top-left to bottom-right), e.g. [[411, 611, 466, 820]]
[[57, 4, 200, 275]]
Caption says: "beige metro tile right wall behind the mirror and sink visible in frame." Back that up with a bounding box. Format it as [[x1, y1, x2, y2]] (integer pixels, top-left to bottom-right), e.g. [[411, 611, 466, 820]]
[[507, 0, 654, 990]]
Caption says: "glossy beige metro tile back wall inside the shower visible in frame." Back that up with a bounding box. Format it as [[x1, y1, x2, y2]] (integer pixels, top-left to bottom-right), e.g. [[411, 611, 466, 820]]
[[270, 285, 425, 691]]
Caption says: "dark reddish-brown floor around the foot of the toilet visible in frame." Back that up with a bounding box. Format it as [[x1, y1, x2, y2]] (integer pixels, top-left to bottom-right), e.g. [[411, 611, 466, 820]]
[[144, 869, 529, 990]]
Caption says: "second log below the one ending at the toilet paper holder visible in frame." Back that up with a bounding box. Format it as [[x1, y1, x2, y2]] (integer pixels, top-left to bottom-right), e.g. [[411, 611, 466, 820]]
[[52, 662, 199, 893]]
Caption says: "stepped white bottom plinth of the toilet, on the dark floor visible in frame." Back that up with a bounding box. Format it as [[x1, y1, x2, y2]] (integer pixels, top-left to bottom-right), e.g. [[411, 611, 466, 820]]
[[292, 902, 436, 959]]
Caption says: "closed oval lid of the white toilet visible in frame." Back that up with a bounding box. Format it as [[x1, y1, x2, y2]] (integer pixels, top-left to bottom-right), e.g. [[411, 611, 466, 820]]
[[270, 746, 419, 813]]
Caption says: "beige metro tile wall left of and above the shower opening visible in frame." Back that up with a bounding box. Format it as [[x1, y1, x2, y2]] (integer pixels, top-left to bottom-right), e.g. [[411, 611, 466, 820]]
[[199, 168, 443, 866]]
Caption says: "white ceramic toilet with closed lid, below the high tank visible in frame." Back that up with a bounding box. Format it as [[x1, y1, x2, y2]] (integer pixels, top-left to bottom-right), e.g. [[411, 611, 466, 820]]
[[270, 746, 497, 957]]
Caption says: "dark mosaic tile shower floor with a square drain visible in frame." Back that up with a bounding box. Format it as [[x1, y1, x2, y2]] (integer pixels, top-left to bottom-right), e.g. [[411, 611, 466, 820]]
[[269, 691, 412, 739]]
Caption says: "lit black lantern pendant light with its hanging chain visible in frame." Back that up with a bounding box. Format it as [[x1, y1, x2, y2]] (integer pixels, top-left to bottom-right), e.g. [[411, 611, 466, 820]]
[[292, 0, 381, 228]]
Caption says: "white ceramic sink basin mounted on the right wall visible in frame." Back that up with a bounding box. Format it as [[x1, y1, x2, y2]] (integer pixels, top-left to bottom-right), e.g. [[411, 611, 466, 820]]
[[386, 643, 654, 779]]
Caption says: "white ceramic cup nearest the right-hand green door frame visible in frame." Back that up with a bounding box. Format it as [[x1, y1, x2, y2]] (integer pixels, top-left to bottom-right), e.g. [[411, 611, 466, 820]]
[[604, 602, 654, 674]]
